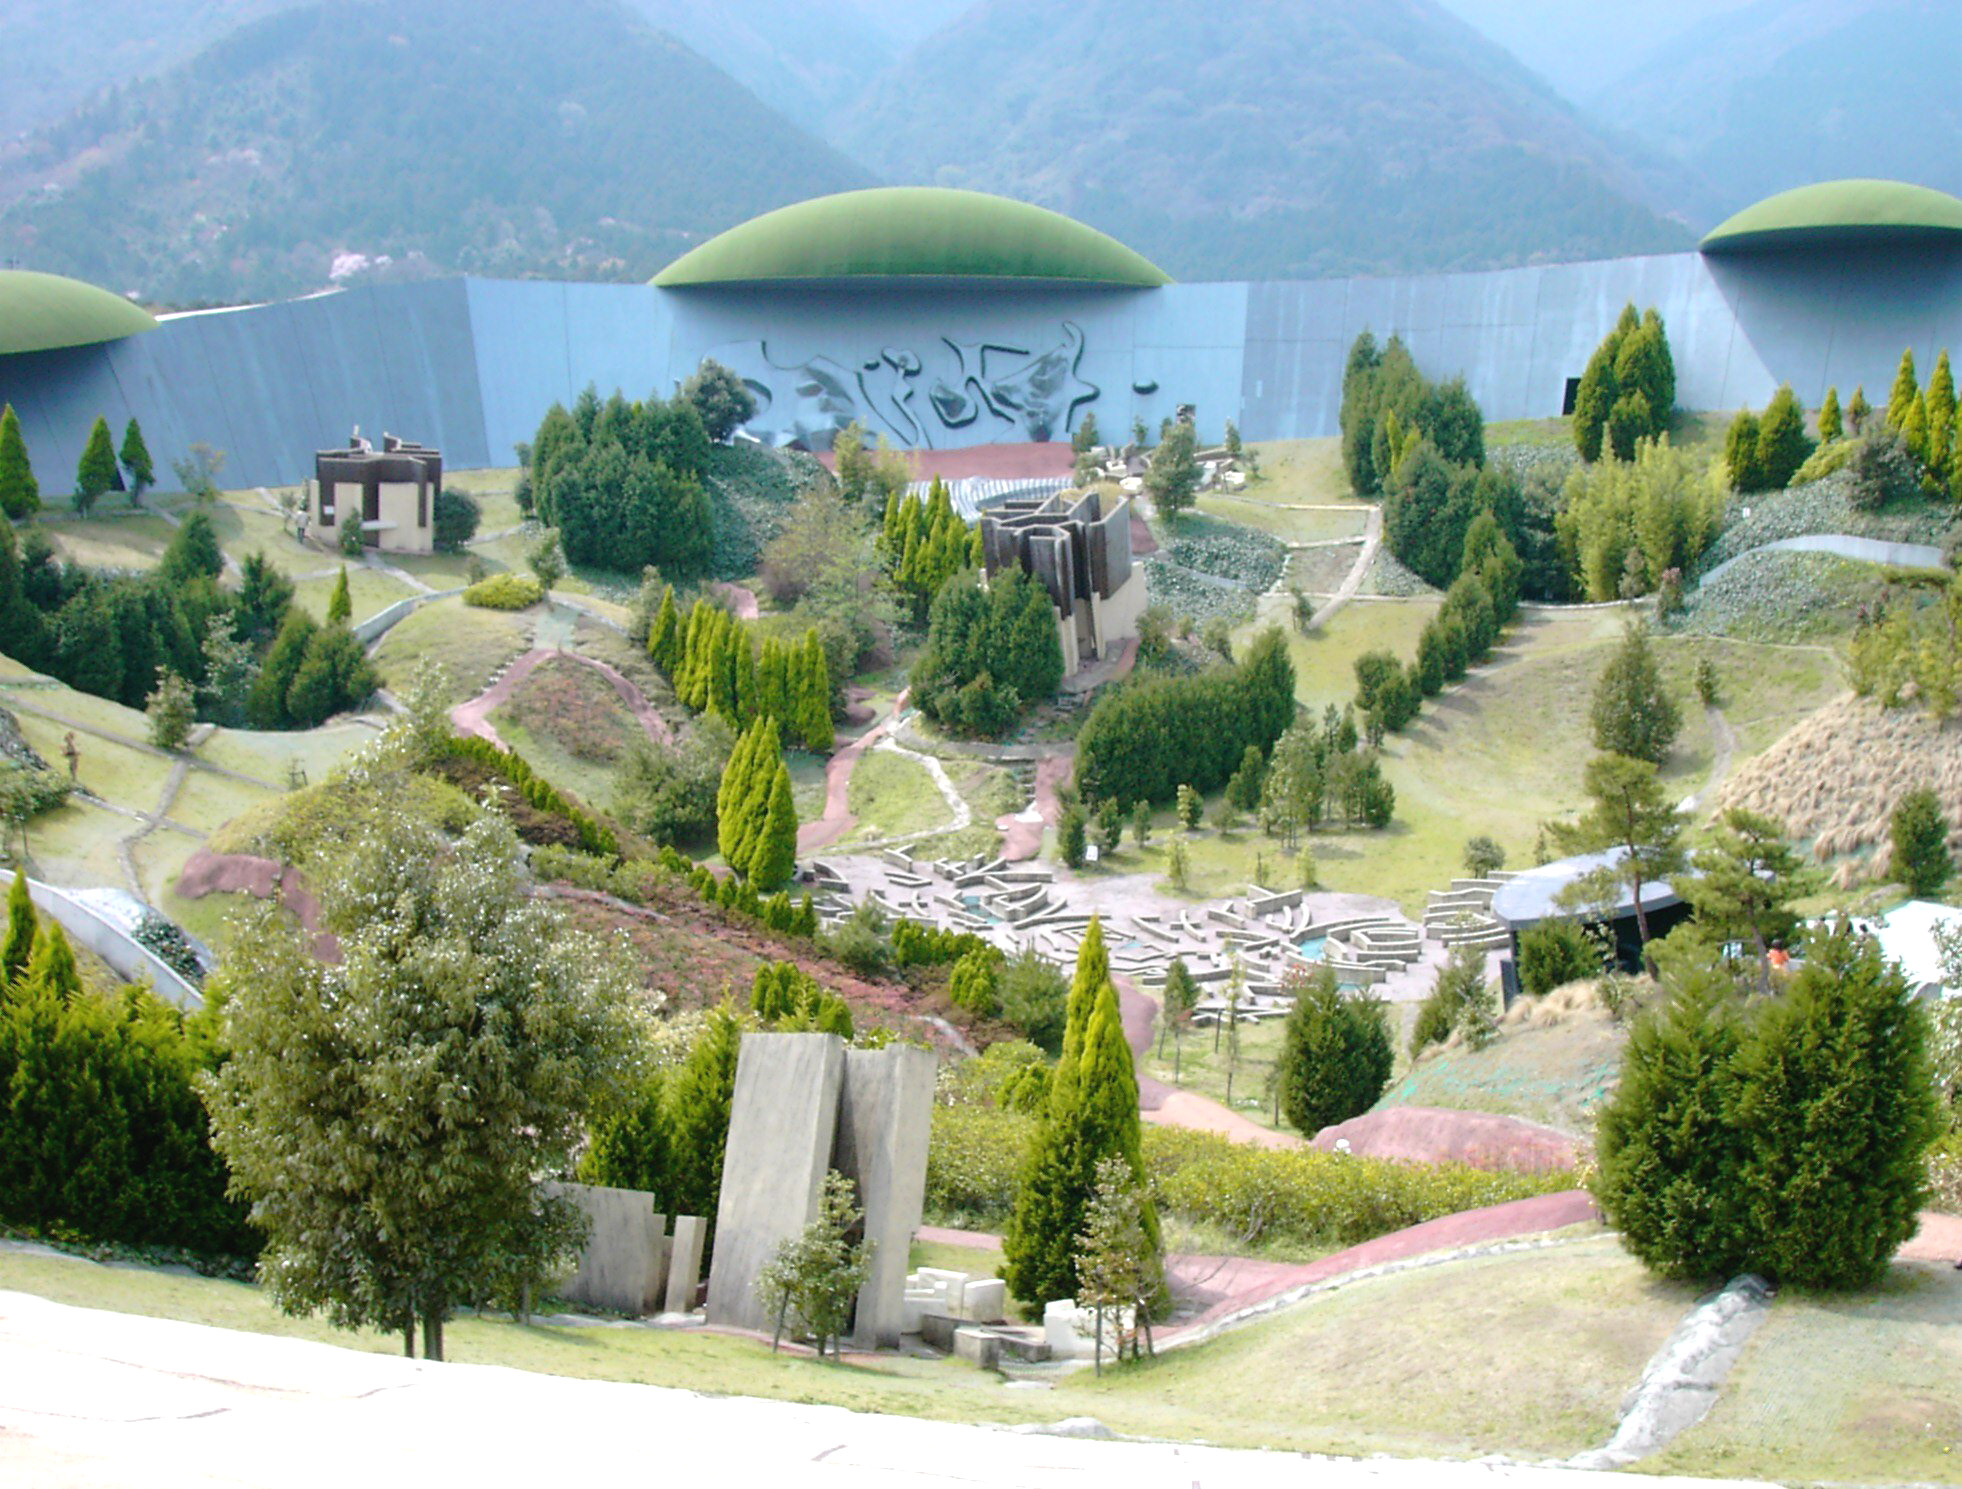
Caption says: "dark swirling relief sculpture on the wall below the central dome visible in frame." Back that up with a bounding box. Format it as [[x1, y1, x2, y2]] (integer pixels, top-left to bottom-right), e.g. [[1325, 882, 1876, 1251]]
[[710, 322, 1099, 449]]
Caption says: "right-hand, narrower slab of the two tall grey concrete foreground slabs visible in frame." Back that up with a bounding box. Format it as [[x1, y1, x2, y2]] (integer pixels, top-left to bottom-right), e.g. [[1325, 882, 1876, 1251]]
[[832, 1044, 940, 1350]]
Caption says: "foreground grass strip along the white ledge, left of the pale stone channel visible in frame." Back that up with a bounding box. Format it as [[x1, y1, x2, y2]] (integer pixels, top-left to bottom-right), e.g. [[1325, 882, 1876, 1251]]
[[0, 1238, 1703, 1458]]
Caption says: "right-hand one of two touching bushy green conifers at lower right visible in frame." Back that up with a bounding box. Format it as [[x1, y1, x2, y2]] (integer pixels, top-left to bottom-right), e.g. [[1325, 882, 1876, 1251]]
[[1734, 932, 1938, 1287]]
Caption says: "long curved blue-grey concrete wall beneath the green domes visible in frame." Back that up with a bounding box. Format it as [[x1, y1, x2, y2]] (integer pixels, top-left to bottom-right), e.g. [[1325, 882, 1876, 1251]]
[[0, 247, 1962, 488]]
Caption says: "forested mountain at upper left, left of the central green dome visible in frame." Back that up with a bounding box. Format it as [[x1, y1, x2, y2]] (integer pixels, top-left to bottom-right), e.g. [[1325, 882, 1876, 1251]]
[[0, 0, 869, 304]]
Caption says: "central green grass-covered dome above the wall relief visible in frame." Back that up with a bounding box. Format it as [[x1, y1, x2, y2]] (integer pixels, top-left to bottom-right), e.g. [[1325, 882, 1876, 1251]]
[[653, 186, 1171, 288]]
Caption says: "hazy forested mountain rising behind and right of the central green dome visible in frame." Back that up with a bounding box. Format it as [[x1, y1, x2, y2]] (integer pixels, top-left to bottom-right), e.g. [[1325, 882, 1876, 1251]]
[[840, 0, 1689, 279]]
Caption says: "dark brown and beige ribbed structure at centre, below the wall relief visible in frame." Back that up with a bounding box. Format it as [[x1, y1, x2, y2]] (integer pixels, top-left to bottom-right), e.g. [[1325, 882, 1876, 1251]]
[[981, 490, 1144, 675]]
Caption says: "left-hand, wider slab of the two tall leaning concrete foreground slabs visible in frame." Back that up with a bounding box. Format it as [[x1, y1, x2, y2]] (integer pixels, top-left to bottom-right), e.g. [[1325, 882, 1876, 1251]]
[[708, 1034, 846, 1330]]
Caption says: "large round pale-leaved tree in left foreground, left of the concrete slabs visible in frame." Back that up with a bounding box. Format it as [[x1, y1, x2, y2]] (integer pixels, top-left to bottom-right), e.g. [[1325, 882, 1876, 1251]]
[[204, 814, 638, 1360]]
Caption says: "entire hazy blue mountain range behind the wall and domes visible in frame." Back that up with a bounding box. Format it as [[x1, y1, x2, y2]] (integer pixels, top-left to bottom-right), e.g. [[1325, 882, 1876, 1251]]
[[0, 0, 1962, 304]]
